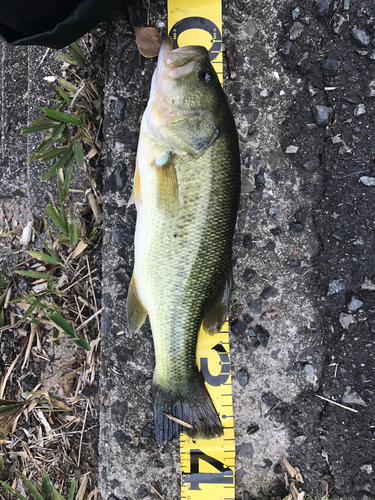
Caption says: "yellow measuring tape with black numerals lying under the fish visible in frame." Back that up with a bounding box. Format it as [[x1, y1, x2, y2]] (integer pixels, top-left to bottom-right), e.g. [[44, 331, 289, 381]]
[[168, 0, 235, 500]]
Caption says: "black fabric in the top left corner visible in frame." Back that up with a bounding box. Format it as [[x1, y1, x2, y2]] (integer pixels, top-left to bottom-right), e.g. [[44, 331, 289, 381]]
[[0, 0, 126, 49]]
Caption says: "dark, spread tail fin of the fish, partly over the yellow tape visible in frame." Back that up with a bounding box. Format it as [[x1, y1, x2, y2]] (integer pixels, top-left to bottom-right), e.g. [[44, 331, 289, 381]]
[[153, 371, 223, 444]]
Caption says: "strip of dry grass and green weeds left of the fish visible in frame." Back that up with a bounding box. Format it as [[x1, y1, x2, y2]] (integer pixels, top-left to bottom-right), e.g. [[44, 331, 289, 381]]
[[0, 28, 104, 500]]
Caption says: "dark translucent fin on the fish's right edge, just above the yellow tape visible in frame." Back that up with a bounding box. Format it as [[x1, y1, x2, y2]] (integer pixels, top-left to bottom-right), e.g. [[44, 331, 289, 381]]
[[203, 270, 232, 335]]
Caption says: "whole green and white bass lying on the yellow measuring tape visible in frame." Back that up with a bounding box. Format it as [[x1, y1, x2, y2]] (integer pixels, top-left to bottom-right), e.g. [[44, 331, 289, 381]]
[[126, 38, 240, 444]]
